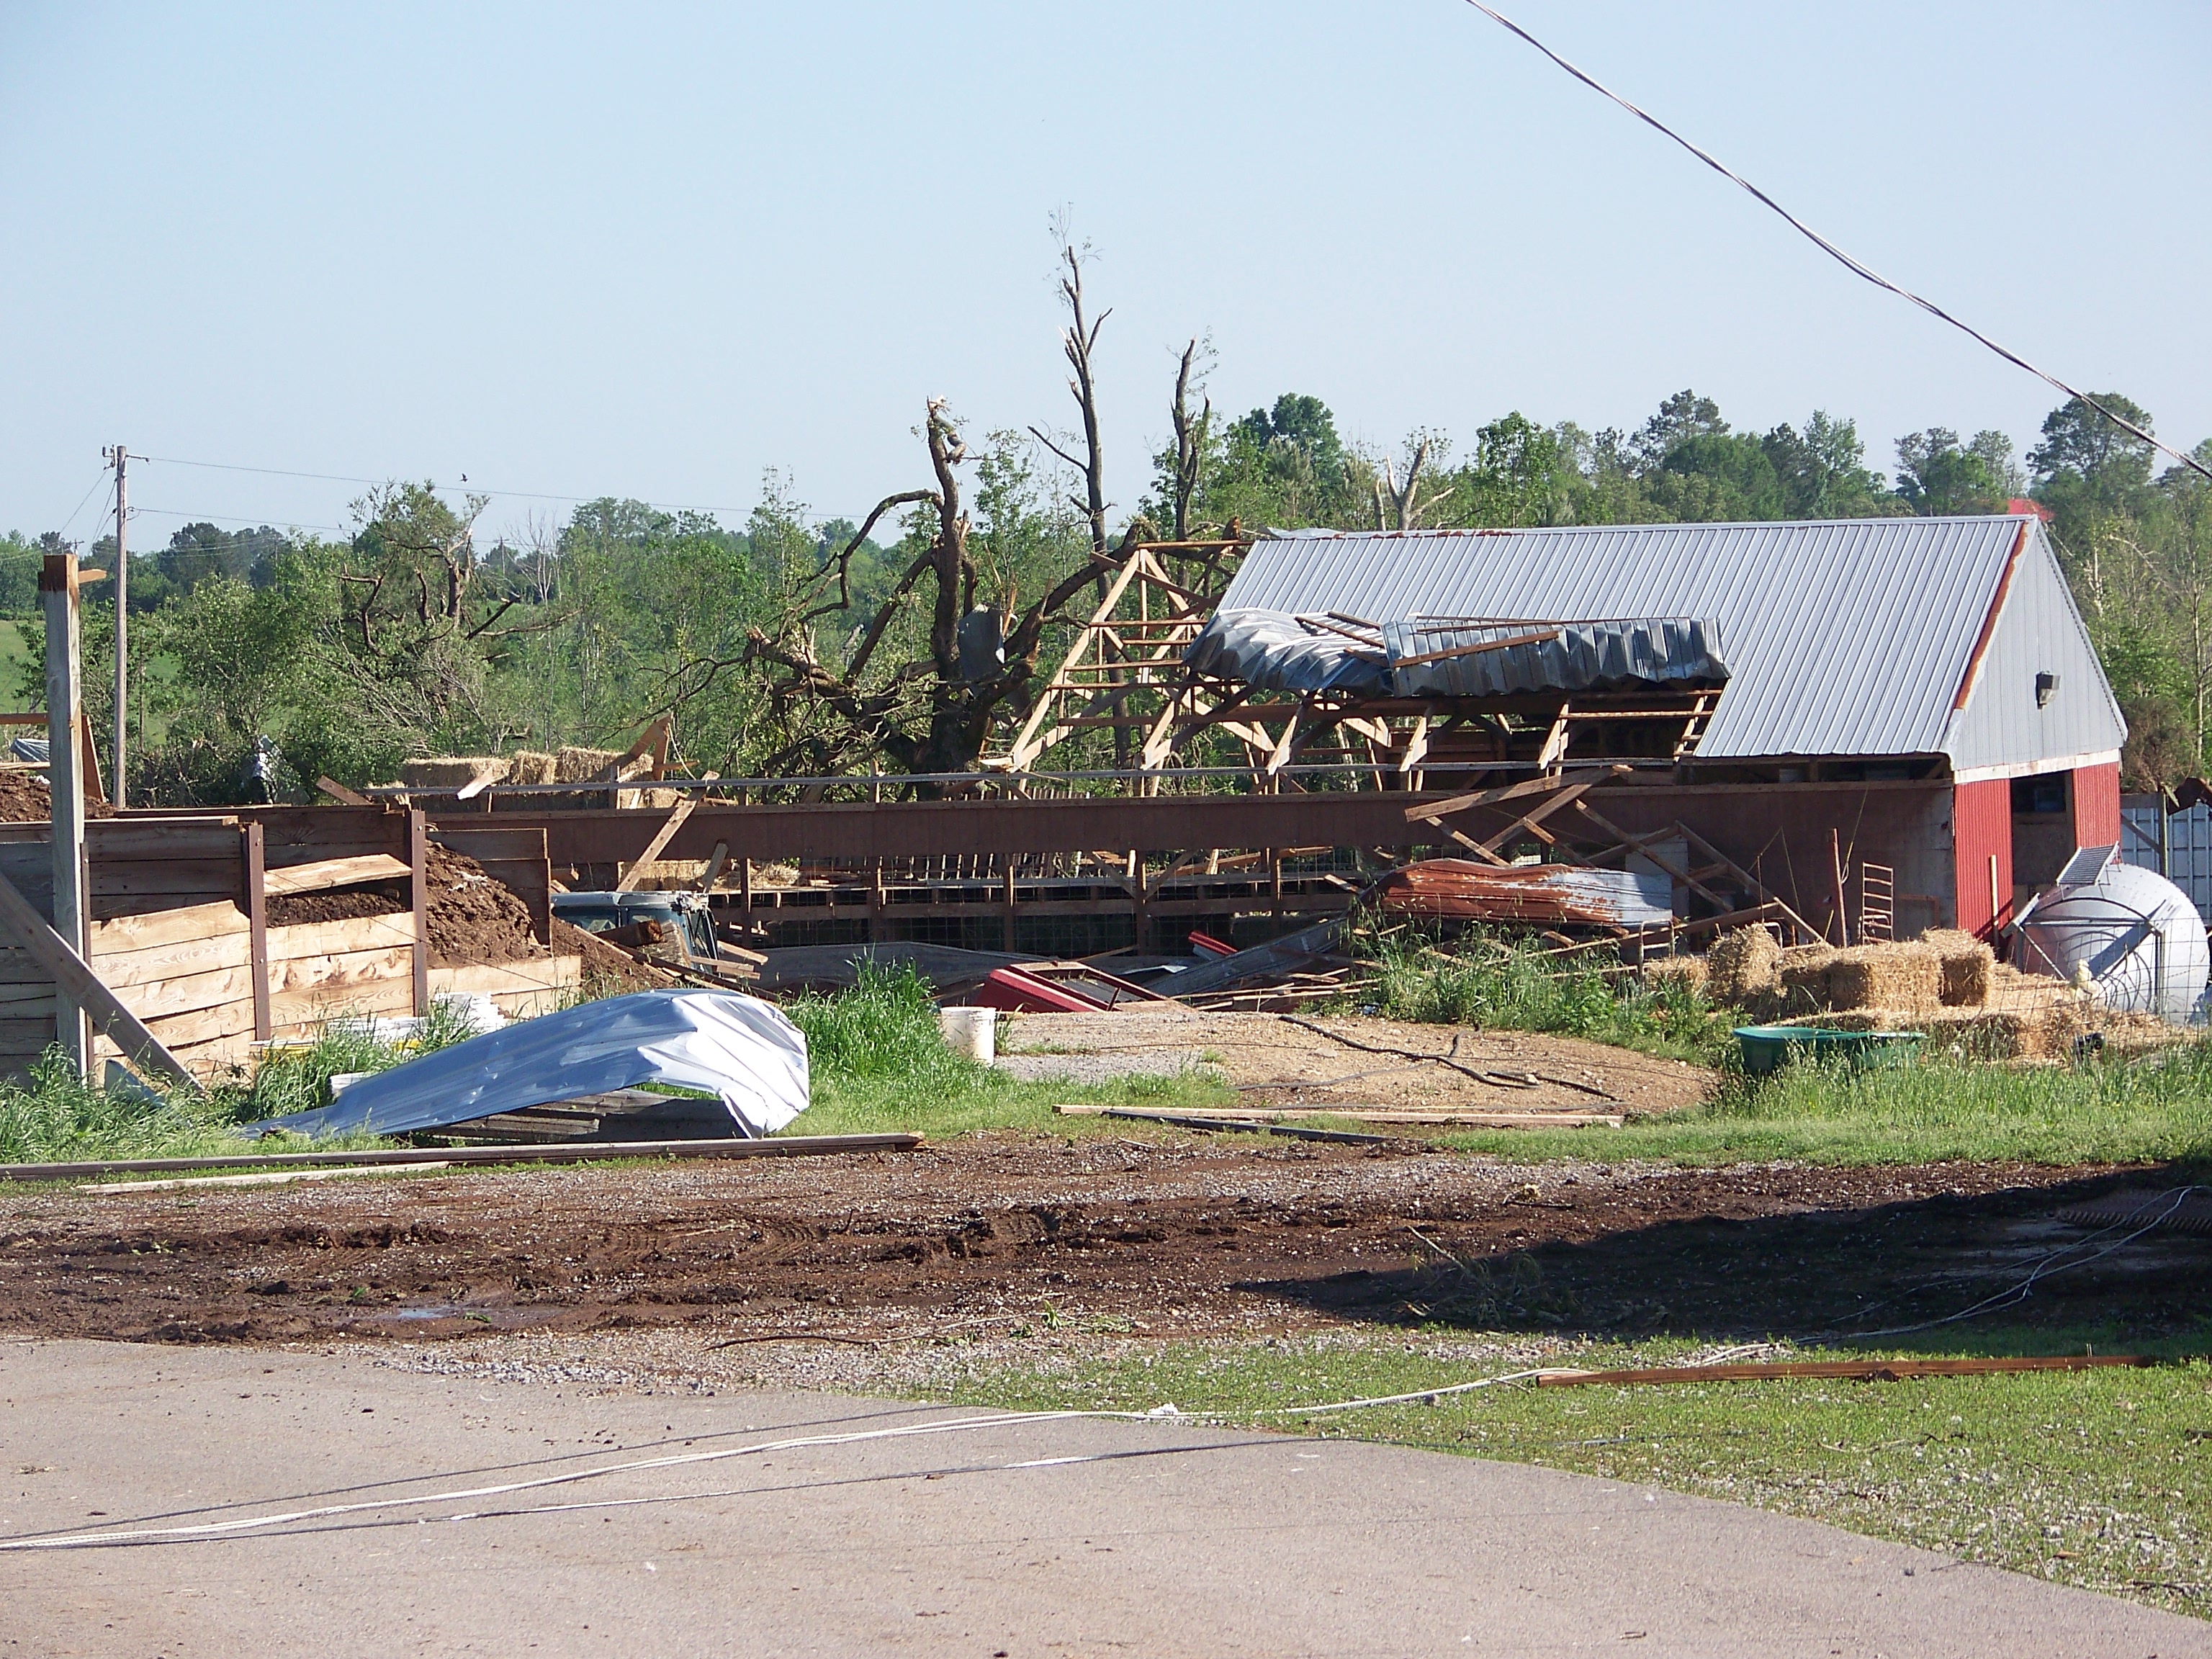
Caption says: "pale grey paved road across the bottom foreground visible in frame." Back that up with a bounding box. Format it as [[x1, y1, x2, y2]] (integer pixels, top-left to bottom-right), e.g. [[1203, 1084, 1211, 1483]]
[[0, 1341, 2212, 1659]]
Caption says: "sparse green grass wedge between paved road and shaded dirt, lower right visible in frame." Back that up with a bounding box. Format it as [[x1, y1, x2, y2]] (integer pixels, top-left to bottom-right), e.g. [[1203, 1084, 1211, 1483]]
[[960, 1331, 2212, 1617]]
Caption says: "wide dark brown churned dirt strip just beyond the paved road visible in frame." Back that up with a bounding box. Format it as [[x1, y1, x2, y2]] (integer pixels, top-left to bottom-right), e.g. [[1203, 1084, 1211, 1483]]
[[0, 1133, 2212, 1347]]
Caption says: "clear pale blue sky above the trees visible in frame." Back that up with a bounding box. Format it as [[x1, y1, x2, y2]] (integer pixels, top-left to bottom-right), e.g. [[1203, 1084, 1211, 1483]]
[[0, 0, 2212, 549]]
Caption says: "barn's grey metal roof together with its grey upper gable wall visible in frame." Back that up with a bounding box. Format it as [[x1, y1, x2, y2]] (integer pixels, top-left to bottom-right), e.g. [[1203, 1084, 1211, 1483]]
[[1195, 518, 2126, 768]]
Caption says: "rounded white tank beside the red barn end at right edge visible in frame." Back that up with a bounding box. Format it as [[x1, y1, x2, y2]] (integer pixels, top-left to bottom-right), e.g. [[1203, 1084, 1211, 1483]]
[[2020, 858, 2212, 1024]]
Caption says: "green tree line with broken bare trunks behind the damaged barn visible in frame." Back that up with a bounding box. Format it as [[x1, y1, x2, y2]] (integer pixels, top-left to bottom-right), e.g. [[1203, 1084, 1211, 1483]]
[[0, 274, 2212, 805]]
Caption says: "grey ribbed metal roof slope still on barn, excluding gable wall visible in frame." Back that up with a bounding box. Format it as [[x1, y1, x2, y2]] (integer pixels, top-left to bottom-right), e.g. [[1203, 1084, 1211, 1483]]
[[1219, 518, 2052, 759]]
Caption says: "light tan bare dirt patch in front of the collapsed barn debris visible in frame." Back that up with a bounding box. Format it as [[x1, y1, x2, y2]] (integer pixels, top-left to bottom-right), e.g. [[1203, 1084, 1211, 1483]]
[[1000, 1004, 1714, 1112]]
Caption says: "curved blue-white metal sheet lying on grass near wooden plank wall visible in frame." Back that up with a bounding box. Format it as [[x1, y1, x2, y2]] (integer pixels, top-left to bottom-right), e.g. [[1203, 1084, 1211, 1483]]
[[243, 991, 809, 1137]]
